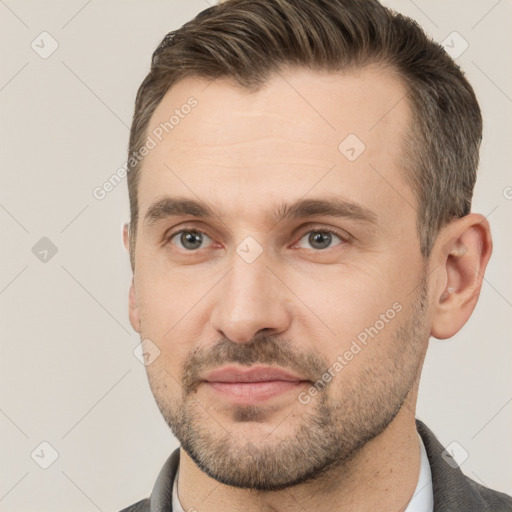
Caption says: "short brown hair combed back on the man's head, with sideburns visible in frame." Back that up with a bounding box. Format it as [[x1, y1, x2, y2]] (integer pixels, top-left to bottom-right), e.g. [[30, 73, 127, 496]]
[[128, 0, 482, 267]]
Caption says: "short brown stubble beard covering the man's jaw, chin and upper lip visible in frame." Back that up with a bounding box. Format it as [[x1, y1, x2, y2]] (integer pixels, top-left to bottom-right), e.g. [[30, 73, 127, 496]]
[[148, 280, 429, 492]]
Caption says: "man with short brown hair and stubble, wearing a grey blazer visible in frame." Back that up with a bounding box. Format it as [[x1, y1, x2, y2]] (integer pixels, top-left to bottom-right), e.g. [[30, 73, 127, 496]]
[[119, 0, 512, 512]]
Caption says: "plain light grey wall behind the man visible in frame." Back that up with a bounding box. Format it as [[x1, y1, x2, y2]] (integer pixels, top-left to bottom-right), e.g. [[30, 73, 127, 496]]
[[0, 0, 512, 512]]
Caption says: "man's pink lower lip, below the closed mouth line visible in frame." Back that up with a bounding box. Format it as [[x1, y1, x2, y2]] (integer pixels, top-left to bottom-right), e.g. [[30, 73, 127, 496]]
[[205, 380, 307, 403]]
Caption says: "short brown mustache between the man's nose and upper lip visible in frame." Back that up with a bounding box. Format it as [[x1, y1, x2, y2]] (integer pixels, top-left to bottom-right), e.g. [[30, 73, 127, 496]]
[[182, 336, 329, 395]]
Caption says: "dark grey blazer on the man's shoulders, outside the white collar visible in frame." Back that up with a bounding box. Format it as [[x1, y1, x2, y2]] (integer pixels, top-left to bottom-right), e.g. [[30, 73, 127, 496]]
[[120, 420, 512, 512]]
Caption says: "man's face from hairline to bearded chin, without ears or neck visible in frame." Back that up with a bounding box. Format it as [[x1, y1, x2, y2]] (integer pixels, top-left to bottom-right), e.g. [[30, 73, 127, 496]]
[[131, 68, 430, 490]]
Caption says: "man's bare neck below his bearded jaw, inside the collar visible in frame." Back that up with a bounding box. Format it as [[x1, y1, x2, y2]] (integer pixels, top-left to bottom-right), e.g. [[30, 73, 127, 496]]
[[178, 388, 420, 512]]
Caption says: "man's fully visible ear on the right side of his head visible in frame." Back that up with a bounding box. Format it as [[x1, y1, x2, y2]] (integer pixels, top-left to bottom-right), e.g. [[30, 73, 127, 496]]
[[431, 213, 492, 339]]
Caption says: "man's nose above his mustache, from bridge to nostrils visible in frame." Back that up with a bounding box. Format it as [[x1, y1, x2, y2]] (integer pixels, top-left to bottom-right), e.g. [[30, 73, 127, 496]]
[[211, 249, 292, 343]]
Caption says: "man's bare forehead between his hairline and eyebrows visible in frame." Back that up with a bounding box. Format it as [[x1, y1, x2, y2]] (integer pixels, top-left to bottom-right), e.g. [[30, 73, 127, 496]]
[[138, 67, 414, 228]]
